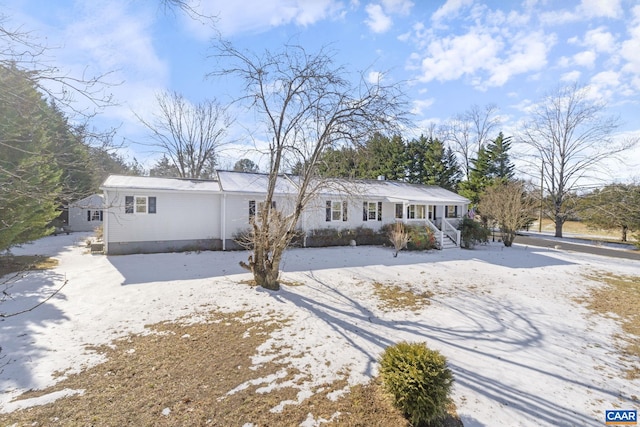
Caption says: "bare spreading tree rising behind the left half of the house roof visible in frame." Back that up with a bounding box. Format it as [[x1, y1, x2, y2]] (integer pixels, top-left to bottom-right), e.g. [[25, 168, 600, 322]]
[[136, 92, 231, 178]]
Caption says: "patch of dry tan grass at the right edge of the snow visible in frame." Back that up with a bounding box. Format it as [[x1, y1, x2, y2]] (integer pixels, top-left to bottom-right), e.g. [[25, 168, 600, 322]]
[[582, 272, 640, 379]]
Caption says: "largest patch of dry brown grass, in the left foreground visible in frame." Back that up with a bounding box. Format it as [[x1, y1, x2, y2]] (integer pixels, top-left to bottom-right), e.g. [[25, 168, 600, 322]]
[[0, 313, 462, 427]]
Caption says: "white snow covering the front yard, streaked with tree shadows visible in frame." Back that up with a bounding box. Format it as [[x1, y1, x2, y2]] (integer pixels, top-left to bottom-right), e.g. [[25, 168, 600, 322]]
[[0, 233, 640, 427]]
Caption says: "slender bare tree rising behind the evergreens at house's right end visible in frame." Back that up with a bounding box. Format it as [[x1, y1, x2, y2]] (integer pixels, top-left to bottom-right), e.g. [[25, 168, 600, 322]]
[[443, 104, 500, 179]]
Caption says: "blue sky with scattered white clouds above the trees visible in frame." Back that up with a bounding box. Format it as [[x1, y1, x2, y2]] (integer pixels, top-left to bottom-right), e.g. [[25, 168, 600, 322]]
[[5, 0, 640, 179]]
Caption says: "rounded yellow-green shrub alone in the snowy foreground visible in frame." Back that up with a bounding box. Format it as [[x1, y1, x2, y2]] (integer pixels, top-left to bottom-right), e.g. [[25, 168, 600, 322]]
[[380, 342, 453, 426]]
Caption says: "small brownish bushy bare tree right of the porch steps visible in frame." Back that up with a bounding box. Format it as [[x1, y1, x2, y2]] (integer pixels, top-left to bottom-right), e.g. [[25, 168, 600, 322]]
[[478, 181, 536, 247]]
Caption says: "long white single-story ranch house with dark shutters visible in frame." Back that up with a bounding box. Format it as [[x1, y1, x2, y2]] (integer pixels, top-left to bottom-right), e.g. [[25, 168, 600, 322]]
[[101, 171, 469, 255]]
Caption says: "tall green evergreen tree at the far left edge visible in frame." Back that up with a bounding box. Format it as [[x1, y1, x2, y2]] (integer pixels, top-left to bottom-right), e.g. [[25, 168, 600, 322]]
[[0, 62, 63, 251]]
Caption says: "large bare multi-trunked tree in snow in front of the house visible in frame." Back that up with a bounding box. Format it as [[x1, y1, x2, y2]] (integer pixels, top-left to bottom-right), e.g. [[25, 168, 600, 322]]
[[212, 41, 406, 290]]
